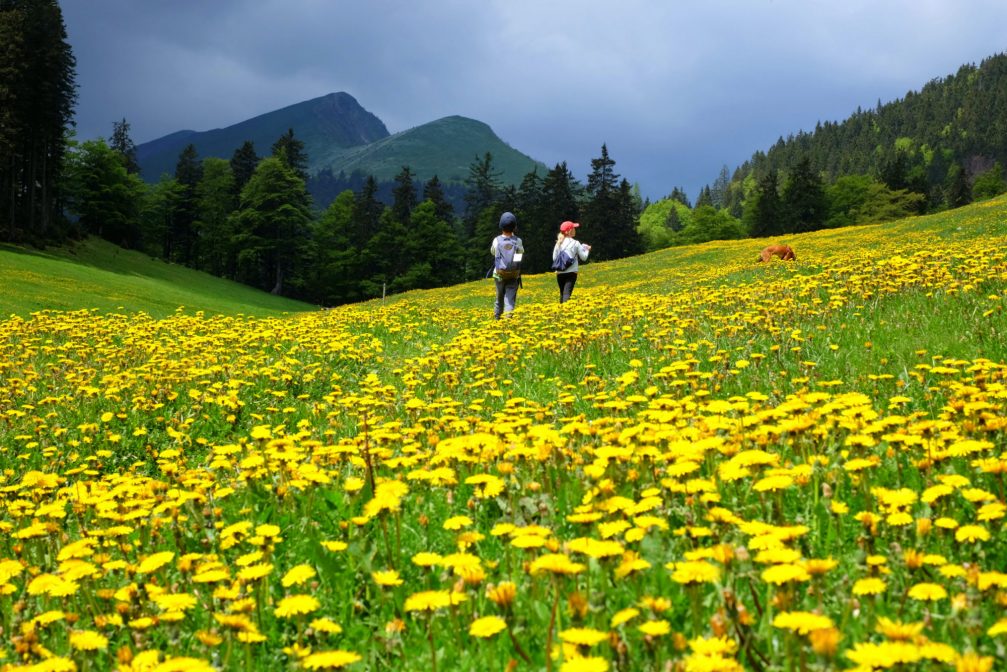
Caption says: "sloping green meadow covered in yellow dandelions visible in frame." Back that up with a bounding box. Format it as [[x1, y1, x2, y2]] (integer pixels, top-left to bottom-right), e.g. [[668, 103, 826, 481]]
[[0, 198, 1007, 672]]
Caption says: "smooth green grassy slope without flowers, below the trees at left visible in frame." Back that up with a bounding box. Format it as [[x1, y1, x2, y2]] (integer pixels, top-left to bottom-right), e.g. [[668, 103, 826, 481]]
[[0, 238, 313, 317]]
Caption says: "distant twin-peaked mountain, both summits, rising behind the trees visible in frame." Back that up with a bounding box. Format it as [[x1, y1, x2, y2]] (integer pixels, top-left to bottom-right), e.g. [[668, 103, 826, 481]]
[[137, 93, 546, 190]]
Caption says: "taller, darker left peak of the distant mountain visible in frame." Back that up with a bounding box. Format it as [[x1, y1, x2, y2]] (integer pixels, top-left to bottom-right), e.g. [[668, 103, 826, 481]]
[[136, 93, 389, 181]]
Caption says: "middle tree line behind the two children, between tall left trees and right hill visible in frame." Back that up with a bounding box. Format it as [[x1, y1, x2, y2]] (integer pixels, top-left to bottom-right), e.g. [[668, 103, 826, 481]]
[[66, 126, 642, 305]]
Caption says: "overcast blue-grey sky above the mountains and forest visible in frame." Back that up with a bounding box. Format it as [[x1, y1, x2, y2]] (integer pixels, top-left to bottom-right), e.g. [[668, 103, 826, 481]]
[[60, 0, 1007, 199]]
